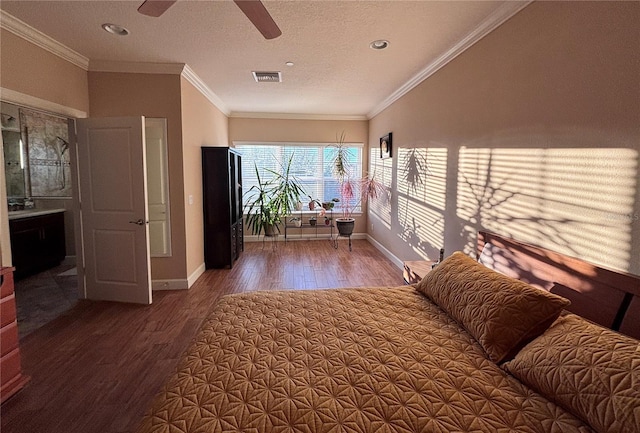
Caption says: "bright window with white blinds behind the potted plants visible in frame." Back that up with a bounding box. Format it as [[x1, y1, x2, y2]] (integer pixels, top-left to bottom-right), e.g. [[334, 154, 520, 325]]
[[235, 143, 363, 212]]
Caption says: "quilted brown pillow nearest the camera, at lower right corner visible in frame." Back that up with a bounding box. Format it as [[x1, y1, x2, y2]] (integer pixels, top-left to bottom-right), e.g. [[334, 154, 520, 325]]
[[504, 314, 640, 433]]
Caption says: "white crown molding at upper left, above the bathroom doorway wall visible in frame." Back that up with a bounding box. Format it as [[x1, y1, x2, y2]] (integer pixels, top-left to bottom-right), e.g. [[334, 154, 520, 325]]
[[0, 11, 89, 71]]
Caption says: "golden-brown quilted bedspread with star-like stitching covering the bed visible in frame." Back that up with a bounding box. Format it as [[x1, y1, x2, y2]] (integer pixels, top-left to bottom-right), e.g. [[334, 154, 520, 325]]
[[139, 286, 592, 433]]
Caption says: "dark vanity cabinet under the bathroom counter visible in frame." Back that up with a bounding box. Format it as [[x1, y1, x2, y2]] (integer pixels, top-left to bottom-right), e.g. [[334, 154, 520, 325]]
[[9, 212, 66, 279]]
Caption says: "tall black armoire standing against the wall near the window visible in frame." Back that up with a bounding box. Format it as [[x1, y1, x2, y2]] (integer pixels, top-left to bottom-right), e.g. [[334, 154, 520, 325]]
[[202, 147, 244, 269]]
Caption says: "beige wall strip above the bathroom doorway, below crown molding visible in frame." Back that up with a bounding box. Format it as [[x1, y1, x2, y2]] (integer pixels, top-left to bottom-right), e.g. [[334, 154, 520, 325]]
[[0, 29, 89, 113]]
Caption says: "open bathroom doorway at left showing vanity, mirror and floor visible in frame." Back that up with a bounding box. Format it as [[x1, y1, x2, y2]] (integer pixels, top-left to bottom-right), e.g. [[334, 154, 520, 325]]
[[0, 102, 78, 338]]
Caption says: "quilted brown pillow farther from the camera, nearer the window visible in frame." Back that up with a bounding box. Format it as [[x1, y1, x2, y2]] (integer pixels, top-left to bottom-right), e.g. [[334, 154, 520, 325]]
[[416, 252, 570, 363]]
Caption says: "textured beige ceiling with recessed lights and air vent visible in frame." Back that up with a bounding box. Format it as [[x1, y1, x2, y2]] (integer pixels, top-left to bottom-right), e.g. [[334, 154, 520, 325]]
[[0, 0, 520, 116]]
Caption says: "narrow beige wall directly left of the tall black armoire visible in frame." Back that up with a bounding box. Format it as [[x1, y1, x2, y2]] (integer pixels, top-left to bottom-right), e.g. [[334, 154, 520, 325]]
[[180, 78, 229, 275]]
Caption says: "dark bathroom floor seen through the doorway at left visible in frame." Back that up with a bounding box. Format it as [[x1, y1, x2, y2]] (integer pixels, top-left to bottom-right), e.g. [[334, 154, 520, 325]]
[[14, 264, 78, 338]]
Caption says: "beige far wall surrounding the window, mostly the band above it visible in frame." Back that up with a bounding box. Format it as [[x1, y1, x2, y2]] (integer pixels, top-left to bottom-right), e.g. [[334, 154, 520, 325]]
[[229, 117, 369, 235]]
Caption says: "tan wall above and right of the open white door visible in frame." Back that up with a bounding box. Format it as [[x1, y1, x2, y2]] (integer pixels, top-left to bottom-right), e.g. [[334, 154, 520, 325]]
[[89, 72, 188, 280]]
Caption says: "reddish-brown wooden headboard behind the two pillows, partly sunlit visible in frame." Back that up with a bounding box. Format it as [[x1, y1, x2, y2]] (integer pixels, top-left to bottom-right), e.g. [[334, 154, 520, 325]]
[[478, 231, 640, 339]]
